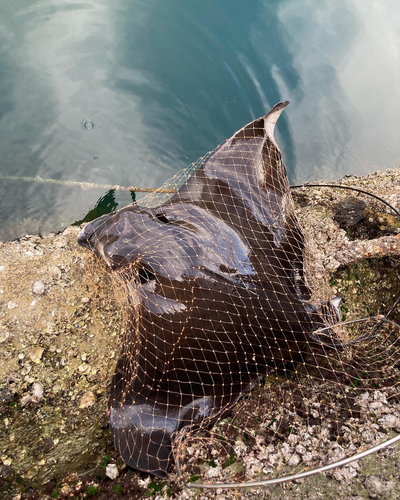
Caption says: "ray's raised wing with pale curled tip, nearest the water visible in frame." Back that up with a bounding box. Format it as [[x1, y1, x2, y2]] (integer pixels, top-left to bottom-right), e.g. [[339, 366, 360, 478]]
[[164, 101, 311, 301]]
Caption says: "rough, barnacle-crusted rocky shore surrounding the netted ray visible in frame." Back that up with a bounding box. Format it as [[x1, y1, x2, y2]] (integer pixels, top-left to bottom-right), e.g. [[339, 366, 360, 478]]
[[0, 168, 400, 500]]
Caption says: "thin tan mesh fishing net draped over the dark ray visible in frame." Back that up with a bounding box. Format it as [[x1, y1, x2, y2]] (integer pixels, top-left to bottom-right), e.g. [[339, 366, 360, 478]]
[[78, 102, 400, 485]]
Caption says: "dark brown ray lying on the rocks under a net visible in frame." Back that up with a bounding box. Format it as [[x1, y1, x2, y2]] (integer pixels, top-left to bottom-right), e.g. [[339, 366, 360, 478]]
[[78, 102, 338, 477]]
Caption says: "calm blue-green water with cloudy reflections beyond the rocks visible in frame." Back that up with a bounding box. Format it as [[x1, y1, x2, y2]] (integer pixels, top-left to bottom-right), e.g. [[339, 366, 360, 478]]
[[0, 0, 400, 239]]
